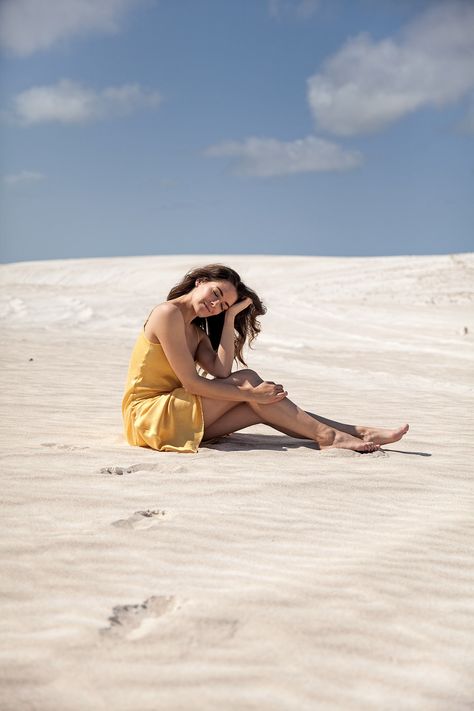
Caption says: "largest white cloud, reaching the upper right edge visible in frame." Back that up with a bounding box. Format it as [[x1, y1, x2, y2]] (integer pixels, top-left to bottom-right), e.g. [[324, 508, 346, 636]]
[[308, 0, 474, 136]]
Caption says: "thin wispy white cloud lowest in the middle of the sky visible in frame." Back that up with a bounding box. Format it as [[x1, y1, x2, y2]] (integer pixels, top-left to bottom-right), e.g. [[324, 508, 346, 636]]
[[206, 136, 362, 178]]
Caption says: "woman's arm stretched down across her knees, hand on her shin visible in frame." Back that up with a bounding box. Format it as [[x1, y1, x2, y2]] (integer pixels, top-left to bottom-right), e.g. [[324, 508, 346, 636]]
[[154, 303, 286, 404]]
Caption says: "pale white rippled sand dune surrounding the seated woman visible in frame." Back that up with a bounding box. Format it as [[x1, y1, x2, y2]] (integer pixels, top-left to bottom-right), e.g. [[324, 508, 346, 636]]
[[0, 254, 474, 711]]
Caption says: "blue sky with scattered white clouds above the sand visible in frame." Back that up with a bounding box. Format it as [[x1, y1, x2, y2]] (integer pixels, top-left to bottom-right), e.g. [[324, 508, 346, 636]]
[[0, 0, 474, 262]]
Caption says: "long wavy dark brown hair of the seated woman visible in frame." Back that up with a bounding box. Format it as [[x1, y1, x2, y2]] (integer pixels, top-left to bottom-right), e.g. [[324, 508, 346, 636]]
[[167, 264, 267, 365]]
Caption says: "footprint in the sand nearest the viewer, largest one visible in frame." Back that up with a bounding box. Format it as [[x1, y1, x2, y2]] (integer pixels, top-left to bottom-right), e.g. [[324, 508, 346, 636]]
[[100, 595, 179, 640]]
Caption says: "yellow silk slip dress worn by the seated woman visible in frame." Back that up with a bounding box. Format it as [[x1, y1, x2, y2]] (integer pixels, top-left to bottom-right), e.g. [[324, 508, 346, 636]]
[[122, 329, 204, 452]]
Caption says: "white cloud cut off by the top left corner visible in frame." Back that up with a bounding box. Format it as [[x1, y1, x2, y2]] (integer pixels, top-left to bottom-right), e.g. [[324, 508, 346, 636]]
[[0, 0, 142, 56]]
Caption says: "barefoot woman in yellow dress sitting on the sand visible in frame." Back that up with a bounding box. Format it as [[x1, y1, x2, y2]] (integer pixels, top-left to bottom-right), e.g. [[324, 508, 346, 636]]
[[122, 264, 408, 452]]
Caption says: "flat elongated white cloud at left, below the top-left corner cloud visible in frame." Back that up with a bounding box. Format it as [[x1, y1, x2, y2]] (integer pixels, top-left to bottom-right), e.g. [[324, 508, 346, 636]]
[[9, 79, 161, 126]]
